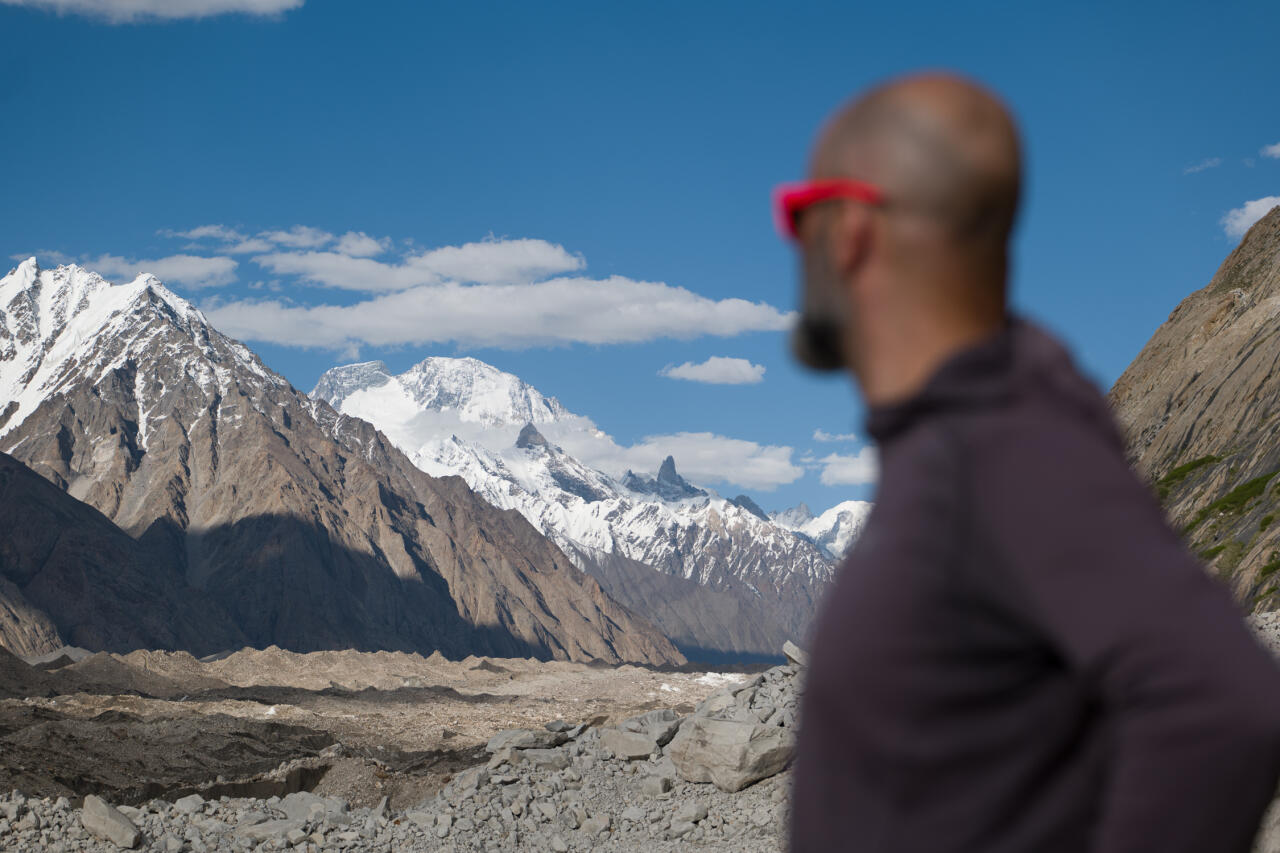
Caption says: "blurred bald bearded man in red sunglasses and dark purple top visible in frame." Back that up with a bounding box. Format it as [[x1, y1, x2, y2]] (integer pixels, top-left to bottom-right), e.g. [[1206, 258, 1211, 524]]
[[778, 74, 1280, 853]]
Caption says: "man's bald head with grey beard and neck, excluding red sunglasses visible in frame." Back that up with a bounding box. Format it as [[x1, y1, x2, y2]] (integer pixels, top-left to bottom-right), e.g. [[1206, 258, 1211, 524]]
[[792, 73, 1021, 384]]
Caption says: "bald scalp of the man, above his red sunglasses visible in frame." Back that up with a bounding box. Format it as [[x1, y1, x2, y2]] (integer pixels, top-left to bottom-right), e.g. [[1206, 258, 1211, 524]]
[[813, 74, 1021, 255]]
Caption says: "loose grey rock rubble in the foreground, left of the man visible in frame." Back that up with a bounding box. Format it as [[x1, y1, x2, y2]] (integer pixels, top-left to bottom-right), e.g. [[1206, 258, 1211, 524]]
[[0, 644, 804, 853]]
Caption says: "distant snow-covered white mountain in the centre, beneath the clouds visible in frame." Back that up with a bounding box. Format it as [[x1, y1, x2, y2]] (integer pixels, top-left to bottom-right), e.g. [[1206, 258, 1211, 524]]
[[312, 357, 854, 653]]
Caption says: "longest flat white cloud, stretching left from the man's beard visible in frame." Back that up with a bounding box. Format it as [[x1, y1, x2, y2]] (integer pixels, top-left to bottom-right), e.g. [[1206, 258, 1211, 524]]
[[207, 275, 794, 351]]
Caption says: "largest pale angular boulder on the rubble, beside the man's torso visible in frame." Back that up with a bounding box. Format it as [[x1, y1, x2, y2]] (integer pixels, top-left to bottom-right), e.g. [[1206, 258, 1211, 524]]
[[667, 717, 795, 793]]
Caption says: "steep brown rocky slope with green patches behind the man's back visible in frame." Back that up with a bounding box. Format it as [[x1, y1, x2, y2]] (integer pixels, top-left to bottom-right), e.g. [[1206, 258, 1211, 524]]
[[1110, 207, 1280, 610]]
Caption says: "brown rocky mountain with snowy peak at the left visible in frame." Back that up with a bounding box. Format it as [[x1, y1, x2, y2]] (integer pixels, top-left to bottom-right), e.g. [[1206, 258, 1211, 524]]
[[0, 259, 682, 663]]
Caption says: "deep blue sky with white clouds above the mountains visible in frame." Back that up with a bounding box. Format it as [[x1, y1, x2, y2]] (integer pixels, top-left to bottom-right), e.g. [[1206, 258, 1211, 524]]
[[0, 0, 1280, 508]]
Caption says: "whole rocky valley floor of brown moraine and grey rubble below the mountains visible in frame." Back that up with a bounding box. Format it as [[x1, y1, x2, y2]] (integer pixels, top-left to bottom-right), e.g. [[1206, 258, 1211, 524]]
[[0, 648, 799, 852]]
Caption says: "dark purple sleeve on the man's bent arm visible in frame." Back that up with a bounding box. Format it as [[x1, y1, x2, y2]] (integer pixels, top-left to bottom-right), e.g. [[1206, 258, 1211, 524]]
[[965, 424, 1280, 853]]
